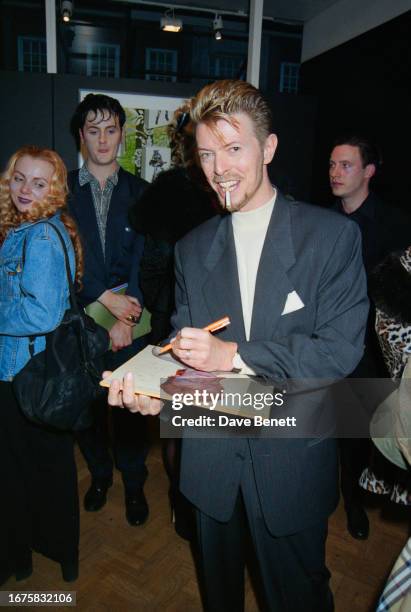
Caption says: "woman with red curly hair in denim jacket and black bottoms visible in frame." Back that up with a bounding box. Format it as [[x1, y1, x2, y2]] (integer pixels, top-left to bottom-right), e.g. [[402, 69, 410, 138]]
[[0, 146, 83, 585]]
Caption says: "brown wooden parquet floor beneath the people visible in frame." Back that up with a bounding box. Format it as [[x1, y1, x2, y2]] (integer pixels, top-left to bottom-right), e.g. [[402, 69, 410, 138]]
[[2, 426, 408, 612]]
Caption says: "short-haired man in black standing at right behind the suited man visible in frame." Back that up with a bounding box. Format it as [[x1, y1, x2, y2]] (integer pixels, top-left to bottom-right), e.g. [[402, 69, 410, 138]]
[[329, 134, 410, 540]]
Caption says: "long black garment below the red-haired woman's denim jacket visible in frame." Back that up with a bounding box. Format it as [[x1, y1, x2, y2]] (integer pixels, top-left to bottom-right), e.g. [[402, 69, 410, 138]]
[[0, 381, 80, 575]]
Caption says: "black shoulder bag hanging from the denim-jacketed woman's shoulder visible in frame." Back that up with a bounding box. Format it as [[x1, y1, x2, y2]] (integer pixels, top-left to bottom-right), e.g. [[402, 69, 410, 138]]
[[13, 221, 109, 431]]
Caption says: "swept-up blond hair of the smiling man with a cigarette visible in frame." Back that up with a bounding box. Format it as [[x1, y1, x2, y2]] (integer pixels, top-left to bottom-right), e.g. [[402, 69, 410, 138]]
[[190, 80, 272, 146]]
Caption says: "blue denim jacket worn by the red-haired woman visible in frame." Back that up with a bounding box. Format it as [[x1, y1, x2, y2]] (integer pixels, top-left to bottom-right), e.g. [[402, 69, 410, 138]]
[[0, 214, 75, 381]]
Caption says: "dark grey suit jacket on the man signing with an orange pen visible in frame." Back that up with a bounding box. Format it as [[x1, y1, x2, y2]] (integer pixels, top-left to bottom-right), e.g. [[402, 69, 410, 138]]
[[172, 194, 368, 535]]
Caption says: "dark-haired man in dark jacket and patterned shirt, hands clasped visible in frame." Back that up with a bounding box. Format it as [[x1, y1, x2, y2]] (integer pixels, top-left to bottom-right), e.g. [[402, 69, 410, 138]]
[[68, 94, 148, 525]]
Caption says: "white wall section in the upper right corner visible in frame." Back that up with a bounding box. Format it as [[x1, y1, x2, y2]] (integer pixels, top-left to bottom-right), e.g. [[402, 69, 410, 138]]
[[301, 0, 411, 62]]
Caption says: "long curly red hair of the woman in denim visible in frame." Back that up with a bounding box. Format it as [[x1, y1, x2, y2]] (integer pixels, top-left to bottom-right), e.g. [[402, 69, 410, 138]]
[[0, 145, 84, 284]]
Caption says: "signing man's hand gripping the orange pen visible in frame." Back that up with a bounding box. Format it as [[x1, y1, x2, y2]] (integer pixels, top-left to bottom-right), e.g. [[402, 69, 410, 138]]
[[171, 327, 238, 372]]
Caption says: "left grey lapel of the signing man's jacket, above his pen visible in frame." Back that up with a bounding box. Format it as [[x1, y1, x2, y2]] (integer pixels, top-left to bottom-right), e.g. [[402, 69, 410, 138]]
[[203, 215, 245, 341]]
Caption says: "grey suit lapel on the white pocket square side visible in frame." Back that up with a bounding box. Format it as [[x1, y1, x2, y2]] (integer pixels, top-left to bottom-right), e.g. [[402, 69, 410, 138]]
[[250, 193, 295, 340]]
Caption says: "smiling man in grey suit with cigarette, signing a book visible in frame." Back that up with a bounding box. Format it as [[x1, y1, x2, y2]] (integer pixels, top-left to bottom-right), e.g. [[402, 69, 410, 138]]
[[109, 81, 368, 612]]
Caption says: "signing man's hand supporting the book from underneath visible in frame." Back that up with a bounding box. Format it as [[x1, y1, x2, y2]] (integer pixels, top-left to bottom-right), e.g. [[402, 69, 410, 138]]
[[103, 372, 163, 415]]
